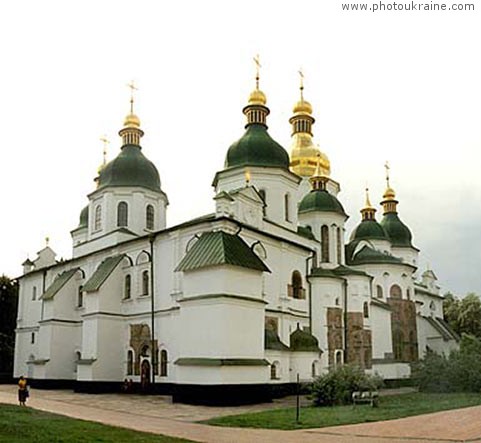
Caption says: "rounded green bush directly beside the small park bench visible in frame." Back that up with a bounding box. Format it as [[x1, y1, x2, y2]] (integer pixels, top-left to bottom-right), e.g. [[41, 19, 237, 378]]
[[311, 365, 382, 406]]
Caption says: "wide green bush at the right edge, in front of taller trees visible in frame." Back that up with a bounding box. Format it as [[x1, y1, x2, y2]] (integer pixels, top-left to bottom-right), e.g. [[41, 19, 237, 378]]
[[413, 335, 481, 392]]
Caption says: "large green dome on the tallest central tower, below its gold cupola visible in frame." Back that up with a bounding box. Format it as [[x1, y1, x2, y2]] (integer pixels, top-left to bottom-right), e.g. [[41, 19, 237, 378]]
[[224, 124, 289, 170]]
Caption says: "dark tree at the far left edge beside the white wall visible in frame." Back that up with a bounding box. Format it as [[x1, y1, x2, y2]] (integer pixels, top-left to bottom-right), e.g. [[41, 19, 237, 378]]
[[0, 275, 18, 375]]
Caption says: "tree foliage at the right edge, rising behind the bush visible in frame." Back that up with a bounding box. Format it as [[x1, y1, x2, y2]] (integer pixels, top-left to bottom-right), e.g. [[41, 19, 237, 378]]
[[443, 292, 481, 338]]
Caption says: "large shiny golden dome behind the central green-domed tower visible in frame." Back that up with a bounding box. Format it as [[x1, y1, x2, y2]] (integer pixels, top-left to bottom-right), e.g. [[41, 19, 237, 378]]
[[291, 136, 331, 177]]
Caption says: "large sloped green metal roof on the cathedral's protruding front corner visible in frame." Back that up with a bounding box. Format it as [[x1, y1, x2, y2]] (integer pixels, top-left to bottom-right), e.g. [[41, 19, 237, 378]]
[[175, 231, 270, 272]]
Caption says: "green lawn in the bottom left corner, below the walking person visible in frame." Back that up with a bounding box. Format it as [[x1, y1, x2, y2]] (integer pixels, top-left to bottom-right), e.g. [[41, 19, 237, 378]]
[[0, 404, 190, 443]]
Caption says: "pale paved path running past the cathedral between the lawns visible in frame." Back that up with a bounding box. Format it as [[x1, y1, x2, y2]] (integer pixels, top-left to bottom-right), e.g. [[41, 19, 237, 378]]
[[0, 385, 481, 443]]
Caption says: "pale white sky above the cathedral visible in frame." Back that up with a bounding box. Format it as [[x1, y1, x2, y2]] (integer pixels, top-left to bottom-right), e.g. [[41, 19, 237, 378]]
[[0, 0, 481, 295]]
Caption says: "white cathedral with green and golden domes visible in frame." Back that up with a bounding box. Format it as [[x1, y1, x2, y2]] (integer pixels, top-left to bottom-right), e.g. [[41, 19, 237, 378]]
[[14, 69, 459, 404]]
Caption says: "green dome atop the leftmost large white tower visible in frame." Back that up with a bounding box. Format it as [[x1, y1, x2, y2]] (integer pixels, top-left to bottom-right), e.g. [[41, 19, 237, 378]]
[[98, 145, 160, 191]]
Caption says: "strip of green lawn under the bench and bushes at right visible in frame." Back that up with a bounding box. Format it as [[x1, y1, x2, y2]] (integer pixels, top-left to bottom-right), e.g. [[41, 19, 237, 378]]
[[204, 393, 481, 429]]
